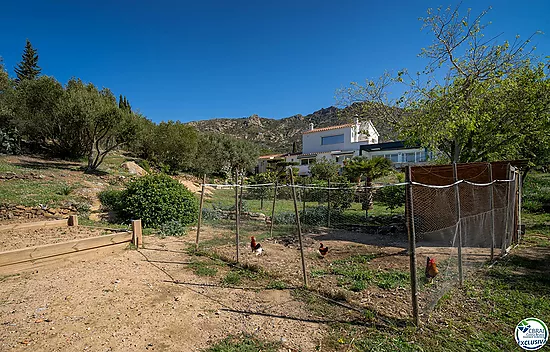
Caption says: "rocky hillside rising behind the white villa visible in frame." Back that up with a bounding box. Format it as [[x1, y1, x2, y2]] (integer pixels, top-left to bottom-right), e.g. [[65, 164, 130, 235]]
[[189, 106, 396, 153]]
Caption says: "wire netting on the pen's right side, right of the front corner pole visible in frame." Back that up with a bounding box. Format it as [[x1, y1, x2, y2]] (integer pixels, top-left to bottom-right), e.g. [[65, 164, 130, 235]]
[[411, 164, 519, 314]]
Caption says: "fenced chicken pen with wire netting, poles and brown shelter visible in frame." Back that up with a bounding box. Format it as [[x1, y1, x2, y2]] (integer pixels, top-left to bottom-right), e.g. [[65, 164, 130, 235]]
[[196, 162, 521, 323]]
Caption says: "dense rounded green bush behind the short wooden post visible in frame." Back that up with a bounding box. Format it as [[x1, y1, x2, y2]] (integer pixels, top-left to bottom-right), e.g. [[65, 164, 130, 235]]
[[118, 174, 199, 228]]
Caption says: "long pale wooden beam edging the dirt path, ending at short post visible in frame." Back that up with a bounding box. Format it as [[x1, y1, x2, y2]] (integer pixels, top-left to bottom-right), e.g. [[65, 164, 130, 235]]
[[0, 232, 132, 267]]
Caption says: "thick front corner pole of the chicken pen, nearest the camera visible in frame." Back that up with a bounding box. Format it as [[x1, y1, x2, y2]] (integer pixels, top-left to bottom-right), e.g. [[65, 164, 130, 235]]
[[405, 166, 420, 326]]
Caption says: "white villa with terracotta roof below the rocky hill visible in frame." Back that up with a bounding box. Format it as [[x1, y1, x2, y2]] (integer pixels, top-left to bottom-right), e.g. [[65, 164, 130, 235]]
[[255, 119, 434, 175]]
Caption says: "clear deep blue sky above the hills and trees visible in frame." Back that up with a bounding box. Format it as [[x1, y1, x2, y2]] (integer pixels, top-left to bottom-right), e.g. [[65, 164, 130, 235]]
[[0, 0, 550, 122]]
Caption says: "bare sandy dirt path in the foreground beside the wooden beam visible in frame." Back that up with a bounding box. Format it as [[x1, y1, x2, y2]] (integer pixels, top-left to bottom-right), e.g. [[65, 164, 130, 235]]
[[0, 237, 325, 351]]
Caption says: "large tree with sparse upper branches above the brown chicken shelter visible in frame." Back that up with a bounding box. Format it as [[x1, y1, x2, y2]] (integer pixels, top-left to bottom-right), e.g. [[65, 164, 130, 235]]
[[338, 5, 544, 162]]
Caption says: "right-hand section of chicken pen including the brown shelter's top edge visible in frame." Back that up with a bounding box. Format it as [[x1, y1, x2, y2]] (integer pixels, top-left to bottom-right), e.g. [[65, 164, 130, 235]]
[[406, 161, 524, 319]]
